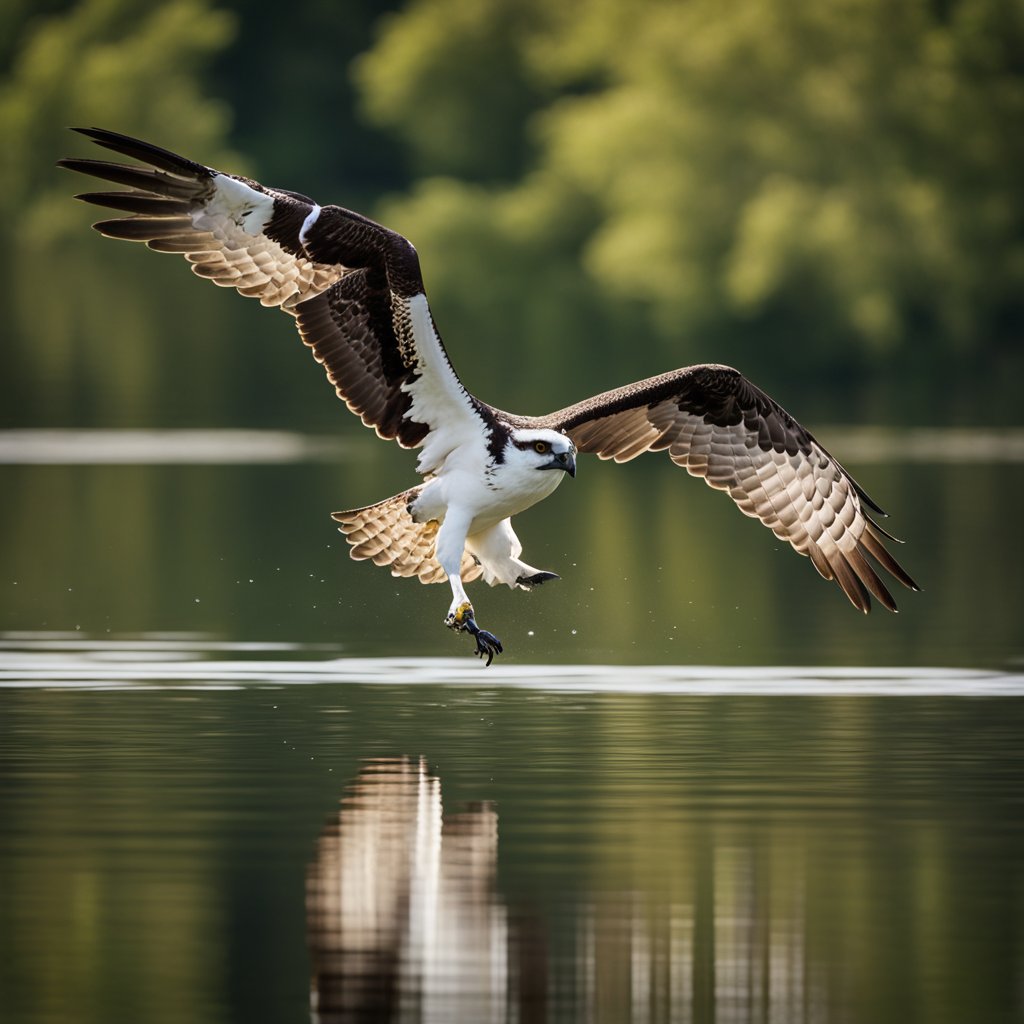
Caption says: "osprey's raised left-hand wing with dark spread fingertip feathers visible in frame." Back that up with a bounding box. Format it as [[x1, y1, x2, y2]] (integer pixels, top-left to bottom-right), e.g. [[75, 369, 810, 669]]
[[59, 128, 493, 464]]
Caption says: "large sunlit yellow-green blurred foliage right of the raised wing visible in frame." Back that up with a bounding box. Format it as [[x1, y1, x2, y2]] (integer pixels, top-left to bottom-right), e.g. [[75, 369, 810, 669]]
[[359, 0, 1024, 413]]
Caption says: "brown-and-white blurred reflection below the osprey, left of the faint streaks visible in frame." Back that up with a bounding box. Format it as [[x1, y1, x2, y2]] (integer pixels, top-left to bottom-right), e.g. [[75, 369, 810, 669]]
[[306, 758, 508, 1024]]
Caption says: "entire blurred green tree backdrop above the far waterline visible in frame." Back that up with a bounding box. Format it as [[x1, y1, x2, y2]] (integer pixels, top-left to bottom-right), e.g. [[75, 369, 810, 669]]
[[0, 0, 1024, 425]]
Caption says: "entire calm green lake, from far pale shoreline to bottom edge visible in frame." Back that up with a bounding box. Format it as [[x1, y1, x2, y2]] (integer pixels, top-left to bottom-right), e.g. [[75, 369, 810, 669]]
[[0, 434, 1024, 1024]]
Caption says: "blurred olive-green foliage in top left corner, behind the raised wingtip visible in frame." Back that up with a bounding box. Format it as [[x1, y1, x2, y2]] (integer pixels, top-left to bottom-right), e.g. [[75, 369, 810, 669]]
[[0, 0, 241, 250]]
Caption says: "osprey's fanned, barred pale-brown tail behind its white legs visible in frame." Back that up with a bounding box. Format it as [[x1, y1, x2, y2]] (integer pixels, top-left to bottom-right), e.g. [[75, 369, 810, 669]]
[[331, 484, 483, 583]]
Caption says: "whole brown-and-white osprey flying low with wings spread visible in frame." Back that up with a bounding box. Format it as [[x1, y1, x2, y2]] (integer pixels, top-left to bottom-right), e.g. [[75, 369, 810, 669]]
[[59, 128, 918, 665]]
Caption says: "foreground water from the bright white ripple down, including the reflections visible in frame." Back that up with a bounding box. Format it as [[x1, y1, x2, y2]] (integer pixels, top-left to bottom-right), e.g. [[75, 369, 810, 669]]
[[0, 635, 1024, 1022]]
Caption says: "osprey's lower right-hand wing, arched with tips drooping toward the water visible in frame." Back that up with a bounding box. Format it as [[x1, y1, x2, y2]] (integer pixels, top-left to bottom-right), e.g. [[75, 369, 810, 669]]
[[540, 366, 918, 611]]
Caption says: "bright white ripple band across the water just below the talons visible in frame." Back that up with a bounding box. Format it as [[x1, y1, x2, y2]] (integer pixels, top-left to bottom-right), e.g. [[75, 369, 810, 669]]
[[0, 633, 1024, 697]]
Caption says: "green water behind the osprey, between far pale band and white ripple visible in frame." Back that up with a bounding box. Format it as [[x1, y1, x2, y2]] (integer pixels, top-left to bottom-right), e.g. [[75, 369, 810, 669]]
[[0, 430, 1024, 669]]
